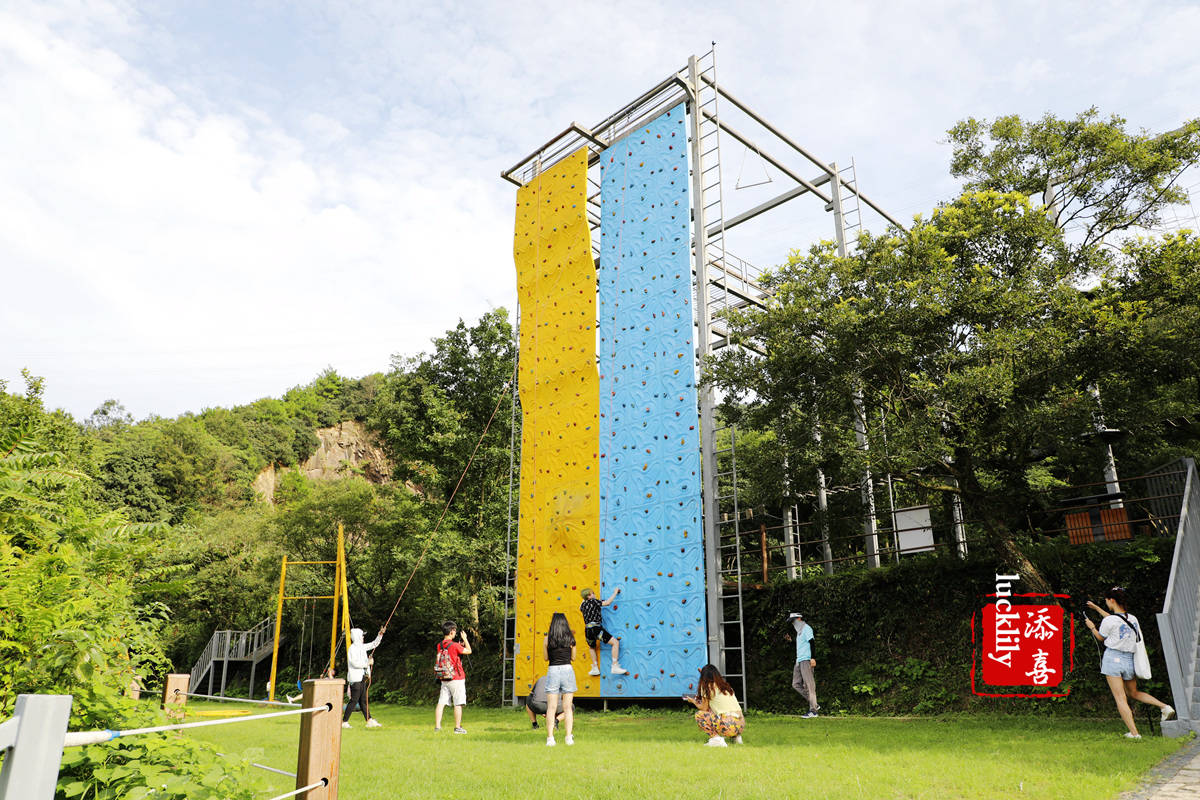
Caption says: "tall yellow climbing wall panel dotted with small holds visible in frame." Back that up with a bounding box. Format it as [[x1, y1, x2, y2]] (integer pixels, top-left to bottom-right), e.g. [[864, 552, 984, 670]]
[[512, 149, 600, 697]]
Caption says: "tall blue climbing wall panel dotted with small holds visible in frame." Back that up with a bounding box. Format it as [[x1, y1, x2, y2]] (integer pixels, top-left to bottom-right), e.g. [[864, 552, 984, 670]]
[[598, 104, 708, 697]]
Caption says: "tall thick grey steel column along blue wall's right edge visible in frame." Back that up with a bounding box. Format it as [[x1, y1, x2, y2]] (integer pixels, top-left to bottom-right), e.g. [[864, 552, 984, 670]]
[[688, 55, 720, 666]]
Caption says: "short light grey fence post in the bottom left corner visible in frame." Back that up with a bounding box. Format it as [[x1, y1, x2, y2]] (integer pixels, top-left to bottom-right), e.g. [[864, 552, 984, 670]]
[[0, 694, 71, 800]]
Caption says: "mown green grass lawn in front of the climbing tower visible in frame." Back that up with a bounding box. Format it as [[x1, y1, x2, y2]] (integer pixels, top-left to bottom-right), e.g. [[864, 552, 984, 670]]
[[188, 702, 1183, 800]]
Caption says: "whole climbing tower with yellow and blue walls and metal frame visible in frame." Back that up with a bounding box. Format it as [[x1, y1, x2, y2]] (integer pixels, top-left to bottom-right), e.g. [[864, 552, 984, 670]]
[[502, 52, 894, 700]]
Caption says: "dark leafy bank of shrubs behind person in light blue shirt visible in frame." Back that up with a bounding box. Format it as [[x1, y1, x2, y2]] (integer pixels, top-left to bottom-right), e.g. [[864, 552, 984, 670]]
[[745, 539, 1174, 714]]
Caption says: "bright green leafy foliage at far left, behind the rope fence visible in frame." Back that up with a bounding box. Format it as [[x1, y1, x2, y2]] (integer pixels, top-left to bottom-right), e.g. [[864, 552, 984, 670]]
[[0, 395, 252, 800]]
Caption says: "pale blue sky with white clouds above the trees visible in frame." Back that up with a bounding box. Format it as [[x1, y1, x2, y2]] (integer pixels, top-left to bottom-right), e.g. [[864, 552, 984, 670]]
[[0, 0, 1200, 419]]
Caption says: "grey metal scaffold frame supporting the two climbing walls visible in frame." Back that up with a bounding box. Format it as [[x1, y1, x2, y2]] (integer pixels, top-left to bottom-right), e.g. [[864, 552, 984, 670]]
[[500, 44, 904, 700]]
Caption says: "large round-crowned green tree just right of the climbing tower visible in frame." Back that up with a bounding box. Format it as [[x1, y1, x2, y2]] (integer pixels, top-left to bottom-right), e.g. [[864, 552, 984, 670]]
[[712, 192, 1135, 582]]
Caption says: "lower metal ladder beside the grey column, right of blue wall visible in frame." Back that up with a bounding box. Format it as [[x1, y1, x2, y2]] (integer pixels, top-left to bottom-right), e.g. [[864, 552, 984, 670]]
[[715, 426, 748, 704]]
